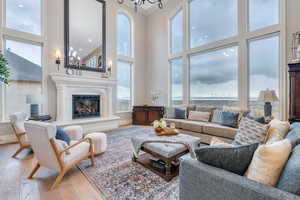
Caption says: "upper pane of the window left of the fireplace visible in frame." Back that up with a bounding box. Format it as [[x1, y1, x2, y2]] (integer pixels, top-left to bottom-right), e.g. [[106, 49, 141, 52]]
[[5, 0, 42, 35]]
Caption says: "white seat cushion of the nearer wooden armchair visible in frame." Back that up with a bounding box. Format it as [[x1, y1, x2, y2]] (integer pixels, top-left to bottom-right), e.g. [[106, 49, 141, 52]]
[[63, 141, 90, 165]]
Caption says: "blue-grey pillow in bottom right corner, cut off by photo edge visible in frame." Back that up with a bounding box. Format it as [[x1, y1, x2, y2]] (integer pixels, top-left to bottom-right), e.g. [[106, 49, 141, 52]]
[[277, 145, 300, 195]]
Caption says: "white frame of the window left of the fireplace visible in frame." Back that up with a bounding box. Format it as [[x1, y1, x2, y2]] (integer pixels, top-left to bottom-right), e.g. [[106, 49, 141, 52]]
[[0, 0, 48, 123]]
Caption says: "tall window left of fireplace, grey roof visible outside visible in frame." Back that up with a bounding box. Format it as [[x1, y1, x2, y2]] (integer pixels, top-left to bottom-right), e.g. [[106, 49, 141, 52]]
[[0, 0, 45, 120]]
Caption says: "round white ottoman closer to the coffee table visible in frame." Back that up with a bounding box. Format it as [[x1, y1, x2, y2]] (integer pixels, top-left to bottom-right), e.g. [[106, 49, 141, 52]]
[[85, 133, 107, 156]]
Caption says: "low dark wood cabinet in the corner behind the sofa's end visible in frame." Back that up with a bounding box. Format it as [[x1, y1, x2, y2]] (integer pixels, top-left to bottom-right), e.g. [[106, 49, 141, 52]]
[[132, 106, 165, 125]]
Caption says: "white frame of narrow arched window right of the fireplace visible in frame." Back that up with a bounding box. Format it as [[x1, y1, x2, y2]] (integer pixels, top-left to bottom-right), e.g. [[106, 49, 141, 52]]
[[116, 9, 135, 113]]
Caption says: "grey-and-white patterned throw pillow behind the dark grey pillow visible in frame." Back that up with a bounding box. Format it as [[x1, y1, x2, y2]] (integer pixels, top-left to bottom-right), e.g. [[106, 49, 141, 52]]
[[233, 117, 268, 145]]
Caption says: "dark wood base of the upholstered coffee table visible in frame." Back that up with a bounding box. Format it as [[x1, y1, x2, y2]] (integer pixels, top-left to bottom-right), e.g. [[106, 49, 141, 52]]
[[132, 146, 189, 182]]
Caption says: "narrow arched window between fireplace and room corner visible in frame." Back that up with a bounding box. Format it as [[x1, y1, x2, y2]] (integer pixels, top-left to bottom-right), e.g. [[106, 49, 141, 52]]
[[117, 13, 134, 112]]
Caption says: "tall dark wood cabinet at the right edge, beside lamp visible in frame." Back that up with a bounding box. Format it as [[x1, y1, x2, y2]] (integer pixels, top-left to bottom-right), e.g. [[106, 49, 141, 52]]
[[289, 63, 300, 122]]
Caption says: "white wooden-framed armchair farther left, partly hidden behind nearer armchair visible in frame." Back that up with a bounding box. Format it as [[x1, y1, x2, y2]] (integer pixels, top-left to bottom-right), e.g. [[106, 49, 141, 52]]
[[9, 112, 31, 158]]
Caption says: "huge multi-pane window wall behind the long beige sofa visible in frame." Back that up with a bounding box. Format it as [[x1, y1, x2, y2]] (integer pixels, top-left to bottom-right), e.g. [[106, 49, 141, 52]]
[[169, 0, 286, 118]]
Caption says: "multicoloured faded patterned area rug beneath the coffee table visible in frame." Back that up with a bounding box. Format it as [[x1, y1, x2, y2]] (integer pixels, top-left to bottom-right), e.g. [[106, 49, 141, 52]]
[[78, 127, 179, 200]]
